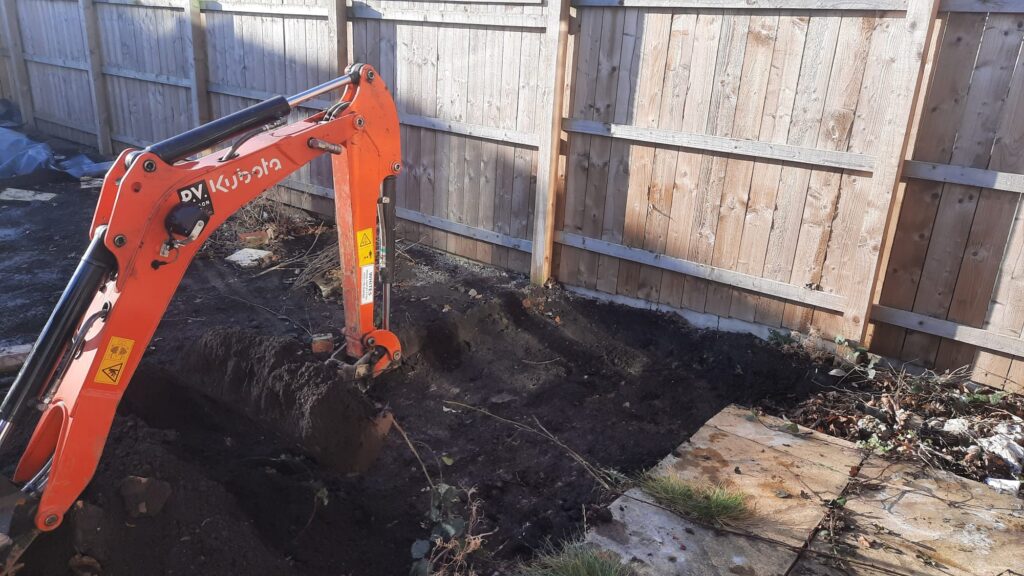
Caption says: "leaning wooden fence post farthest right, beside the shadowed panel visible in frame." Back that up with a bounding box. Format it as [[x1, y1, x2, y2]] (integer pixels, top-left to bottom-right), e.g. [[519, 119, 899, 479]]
[[842, 0, 940, 341]]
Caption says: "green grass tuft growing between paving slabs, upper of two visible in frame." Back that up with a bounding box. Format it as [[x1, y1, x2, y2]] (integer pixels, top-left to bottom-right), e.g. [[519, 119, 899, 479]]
[[640, 474, 751, 526]]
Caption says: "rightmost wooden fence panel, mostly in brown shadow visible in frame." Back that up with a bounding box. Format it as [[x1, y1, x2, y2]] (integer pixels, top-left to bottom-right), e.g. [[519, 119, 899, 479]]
[[872, 5, 1024, 389]]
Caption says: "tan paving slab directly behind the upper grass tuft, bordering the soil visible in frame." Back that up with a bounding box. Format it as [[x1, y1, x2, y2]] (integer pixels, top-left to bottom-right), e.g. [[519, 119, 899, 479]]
[[653, 425, 850, 546]]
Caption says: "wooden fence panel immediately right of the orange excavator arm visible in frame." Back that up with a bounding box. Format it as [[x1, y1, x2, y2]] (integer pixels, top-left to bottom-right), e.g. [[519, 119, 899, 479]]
[[349, 0, 547, 272]]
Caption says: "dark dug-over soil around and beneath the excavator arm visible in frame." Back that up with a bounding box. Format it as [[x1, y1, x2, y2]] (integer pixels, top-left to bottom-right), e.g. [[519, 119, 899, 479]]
[[0, 177, 816, 576]]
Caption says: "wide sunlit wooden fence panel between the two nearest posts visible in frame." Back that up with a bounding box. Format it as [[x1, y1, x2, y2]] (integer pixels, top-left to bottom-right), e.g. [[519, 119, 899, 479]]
[[557, 2, 934, 338]]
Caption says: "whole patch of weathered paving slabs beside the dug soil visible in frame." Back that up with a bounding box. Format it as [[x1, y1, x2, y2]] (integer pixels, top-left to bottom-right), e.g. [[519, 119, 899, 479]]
[[588, 406, 1024, 576]]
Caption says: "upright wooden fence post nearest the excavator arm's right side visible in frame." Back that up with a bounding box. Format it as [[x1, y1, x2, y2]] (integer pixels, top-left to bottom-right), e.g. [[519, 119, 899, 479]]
[[529, 0, 569, 284]]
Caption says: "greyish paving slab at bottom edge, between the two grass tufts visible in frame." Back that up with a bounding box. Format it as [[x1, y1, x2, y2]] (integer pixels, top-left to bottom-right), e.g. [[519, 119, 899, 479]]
[[587, 489, 797, 576]]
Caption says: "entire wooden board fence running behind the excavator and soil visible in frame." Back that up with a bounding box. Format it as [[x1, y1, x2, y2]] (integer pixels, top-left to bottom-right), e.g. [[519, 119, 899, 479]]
[[18, 0, 1024, 383]]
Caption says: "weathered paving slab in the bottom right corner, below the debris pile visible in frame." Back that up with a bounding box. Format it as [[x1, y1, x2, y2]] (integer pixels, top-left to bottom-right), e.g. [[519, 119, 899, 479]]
[[812, 456, 1024, 576]]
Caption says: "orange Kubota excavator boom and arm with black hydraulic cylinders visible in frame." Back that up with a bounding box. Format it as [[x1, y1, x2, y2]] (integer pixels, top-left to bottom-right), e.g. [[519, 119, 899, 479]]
[[0, 64, 401, 574]]
